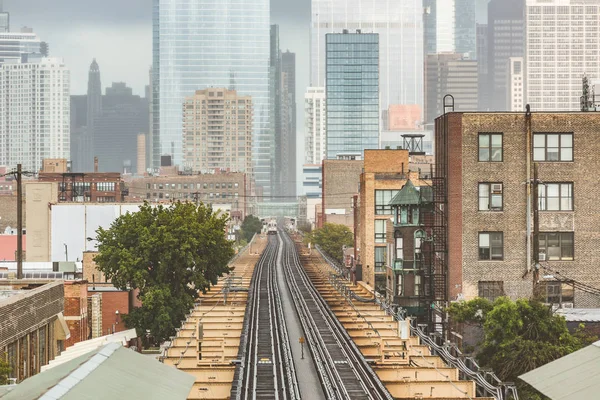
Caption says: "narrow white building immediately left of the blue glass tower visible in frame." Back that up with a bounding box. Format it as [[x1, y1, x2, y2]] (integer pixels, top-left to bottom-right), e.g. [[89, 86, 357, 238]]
[[304, 87, 327, 164]]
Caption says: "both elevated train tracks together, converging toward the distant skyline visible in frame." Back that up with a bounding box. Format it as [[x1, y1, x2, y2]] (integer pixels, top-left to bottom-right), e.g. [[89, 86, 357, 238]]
[[231, 231, 392, 400]]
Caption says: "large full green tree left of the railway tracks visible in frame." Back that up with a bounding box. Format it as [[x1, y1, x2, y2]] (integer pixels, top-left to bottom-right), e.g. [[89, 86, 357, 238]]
[[94, 202, 234, 344]]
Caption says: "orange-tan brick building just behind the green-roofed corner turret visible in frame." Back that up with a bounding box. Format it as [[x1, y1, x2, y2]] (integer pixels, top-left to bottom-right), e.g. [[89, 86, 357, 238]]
[[355, 150, 430, 293]]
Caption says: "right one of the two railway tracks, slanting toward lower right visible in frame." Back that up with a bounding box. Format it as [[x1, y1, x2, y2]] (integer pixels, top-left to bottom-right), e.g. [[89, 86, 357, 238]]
[[277, 233, 392, 400]]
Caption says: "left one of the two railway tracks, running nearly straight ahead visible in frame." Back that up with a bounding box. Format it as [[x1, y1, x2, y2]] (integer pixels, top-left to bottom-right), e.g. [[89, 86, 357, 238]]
[[231, 235, 300, 400]]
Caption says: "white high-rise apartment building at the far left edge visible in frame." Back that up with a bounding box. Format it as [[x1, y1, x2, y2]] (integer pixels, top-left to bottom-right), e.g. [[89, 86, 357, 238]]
[[0, 56, 71, 172]]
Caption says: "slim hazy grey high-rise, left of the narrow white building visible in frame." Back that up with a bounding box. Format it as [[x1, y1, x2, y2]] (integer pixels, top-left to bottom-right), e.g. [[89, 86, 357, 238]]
[[278, 51, 296, 198]]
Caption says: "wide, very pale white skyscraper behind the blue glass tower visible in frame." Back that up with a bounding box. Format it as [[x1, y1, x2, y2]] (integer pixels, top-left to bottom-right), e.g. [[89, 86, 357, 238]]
[[310, 0, 423, 122]]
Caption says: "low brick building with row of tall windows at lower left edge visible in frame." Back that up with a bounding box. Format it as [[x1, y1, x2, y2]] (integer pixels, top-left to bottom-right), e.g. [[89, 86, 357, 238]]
[[0, 281, 69, 382]]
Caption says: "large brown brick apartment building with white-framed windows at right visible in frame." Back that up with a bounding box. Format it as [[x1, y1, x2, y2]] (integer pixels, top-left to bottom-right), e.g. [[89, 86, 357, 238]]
[[434, 112, 600, 308]]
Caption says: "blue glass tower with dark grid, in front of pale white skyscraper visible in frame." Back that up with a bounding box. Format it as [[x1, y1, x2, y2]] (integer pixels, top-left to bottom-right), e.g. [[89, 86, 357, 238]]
[[325, 33, 379, 159]]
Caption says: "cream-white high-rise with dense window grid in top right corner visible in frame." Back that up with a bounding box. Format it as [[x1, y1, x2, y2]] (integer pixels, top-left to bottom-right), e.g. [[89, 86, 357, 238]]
[[525, 0, 600, 111]]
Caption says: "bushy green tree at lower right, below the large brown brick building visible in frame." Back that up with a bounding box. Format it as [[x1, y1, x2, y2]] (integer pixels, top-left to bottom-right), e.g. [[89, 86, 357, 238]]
[[448, 297, 593, 400]]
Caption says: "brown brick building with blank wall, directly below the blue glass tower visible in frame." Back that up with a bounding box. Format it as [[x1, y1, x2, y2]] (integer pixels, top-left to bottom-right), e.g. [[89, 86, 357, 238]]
[[317, 157, 364, 229]]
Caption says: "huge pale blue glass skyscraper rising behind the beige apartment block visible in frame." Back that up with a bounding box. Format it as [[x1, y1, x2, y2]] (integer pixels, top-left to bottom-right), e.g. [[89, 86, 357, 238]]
[[152, 0, 274, 195]]
